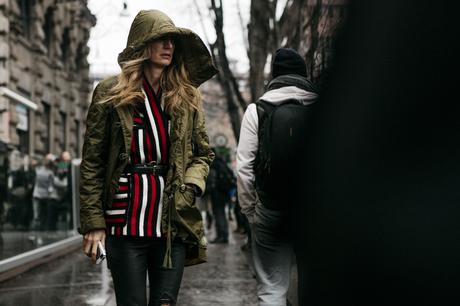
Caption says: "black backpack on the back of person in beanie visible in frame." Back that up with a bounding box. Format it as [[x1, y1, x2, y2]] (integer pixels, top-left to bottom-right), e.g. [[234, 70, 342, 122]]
[[254, 100, 311, 210]]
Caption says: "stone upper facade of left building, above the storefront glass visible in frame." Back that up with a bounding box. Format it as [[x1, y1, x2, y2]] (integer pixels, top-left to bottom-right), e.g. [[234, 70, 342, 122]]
[[0, 0, 96, 160]]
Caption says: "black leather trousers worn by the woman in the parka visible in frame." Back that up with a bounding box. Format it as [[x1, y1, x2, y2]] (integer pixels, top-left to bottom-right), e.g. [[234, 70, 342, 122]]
[[106, 236, 185, 306]]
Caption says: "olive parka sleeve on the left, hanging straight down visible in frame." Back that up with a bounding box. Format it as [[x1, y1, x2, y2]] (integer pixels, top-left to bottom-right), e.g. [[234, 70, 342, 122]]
[[79, 85, 109, 234]]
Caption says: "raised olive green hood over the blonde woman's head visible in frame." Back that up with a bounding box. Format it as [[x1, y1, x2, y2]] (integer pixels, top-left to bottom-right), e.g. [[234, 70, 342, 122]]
[[118, 10, 218, 87]]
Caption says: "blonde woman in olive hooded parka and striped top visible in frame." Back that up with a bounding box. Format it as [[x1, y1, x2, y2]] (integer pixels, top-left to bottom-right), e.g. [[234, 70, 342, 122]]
[[80, 10, 217, 305]]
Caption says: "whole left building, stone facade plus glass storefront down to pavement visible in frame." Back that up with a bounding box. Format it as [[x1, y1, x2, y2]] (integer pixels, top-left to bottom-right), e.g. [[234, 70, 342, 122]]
[[0, 0, 96, 281]]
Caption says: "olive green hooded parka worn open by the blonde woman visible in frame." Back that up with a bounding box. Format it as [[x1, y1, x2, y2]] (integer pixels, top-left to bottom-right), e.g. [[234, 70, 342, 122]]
[[79, 10, 217, 267]]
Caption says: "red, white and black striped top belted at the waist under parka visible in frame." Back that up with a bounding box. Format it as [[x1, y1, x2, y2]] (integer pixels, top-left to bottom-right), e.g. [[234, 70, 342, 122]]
[[105, 78, 169, 237]]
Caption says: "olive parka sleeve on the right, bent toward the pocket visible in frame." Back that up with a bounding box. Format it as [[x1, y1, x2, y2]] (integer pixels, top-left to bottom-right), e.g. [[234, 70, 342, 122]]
[[184, 105, 214, 194]]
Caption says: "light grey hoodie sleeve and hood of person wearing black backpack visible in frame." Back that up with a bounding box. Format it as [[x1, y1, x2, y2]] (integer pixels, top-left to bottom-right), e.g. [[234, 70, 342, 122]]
[[236, 86, 318, 223]]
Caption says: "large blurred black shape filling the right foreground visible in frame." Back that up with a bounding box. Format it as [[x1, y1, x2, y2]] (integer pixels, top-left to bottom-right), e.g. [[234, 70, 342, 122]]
[[293, 0, 460, 306]]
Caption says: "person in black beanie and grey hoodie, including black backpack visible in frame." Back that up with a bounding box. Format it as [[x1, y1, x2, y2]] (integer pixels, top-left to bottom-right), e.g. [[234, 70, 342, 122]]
[[237, 48, 317, 306]]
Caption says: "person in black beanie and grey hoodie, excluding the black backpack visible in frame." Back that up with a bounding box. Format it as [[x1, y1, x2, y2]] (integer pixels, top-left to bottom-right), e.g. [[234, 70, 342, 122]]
[[237, 48, 317, 306]]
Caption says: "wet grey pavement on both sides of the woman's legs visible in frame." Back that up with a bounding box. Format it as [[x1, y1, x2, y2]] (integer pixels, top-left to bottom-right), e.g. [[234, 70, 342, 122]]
[[0, 224, 257, 306]]
